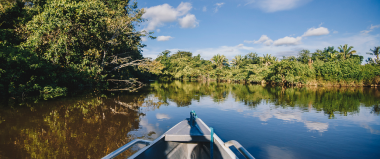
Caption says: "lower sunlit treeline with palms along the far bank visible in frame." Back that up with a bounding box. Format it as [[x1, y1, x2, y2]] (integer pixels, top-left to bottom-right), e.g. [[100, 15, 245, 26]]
[[156, 44, 380, 86]]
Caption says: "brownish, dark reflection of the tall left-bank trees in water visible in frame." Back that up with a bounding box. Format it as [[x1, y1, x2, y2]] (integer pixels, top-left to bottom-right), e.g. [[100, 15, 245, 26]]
[[0, 91, 160, 158]]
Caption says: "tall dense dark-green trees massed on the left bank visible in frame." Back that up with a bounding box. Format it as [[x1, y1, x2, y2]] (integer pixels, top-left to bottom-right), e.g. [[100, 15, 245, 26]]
[[0, 0, 161, 96]]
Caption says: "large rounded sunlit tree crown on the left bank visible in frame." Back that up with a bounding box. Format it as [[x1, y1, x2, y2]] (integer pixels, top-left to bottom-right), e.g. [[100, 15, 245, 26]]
[[23, 0, 143, 66]]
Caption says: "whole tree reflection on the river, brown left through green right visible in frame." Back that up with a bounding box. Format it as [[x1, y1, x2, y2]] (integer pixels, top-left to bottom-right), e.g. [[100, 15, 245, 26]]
[[0, 81, 380, 158]]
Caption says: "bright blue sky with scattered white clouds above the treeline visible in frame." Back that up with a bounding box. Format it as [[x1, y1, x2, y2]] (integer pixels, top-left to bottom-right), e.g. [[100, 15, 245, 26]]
[[137, 0, 380, 60]]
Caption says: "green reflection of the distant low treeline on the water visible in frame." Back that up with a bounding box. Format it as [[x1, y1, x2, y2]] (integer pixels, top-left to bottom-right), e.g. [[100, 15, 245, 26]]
[[151, 81, 380, 118]]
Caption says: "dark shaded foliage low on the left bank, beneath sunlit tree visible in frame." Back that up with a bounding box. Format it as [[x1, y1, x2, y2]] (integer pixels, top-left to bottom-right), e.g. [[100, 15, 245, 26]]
[[0, 43, 103, 95]]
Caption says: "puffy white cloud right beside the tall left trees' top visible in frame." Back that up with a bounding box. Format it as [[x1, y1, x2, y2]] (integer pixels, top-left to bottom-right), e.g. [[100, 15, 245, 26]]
[[142, 2, 196, 31]]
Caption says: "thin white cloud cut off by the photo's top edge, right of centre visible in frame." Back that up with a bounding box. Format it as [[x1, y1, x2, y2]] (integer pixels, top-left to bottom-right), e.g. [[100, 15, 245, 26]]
[[246, 0, 311, 12]]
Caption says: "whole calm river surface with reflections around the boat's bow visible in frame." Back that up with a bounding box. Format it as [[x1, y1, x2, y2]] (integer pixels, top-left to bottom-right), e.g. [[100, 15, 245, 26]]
[[0, 81, 380, 159]]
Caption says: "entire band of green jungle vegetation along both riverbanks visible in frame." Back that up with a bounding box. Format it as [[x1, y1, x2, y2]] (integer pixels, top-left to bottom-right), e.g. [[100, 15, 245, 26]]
[[0, 0, 380, 97]]
